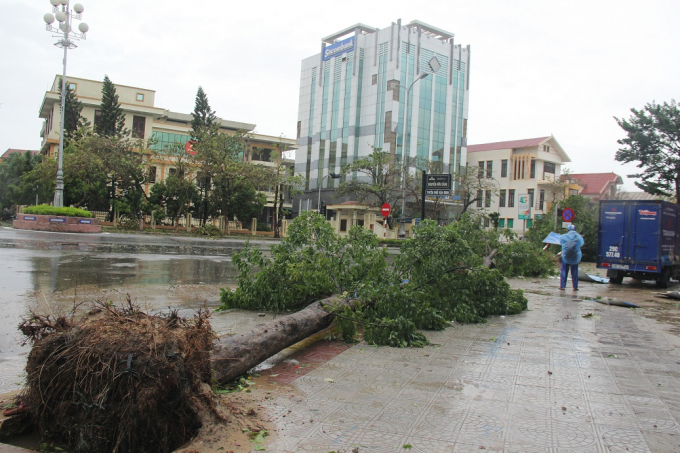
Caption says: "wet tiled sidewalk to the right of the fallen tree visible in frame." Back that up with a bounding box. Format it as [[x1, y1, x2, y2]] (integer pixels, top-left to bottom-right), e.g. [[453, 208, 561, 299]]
[[267, 288, 680, 453]]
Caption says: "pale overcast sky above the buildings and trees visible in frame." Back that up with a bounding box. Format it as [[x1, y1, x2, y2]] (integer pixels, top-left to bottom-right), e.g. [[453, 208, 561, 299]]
[[0, 0, 680, 189]]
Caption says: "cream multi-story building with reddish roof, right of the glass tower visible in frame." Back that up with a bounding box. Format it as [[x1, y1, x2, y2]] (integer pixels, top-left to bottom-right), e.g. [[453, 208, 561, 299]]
[[467, 136, 571, 234]]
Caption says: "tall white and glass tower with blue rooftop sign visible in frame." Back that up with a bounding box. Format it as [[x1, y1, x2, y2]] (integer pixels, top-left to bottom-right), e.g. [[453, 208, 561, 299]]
[[295, 20, 470, 209]]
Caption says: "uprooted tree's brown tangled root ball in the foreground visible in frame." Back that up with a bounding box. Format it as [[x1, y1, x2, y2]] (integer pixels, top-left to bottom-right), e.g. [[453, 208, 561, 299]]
[[20, 300, 214, 452]]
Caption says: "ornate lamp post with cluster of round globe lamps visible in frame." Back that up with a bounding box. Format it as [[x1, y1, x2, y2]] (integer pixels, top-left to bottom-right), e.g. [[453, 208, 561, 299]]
[[43, 0, 90, 208]]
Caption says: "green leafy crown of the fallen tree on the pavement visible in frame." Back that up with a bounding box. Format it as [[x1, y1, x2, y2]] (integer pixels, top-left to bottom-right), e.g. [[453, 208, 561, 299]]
[[221, 212, 527, 347]]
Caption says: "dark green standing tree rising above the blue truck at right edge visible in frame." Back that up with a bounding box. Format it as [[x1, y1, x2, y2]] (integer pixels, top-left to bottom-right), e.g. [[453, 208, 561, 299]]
[[614, 100, 680, 202]]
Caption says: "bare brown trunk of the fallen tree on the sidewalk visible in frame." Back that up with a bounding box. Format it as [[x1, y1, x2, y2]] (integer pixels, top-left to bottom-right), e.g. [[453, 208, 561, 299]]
[[210, 297, 342, 383]]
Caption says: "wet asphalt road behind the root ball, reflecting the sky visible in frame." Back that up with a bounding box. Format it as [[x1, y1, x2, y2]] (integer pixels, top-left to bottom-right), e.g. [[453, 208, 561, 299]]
[[0, 227, 272, 393]]
